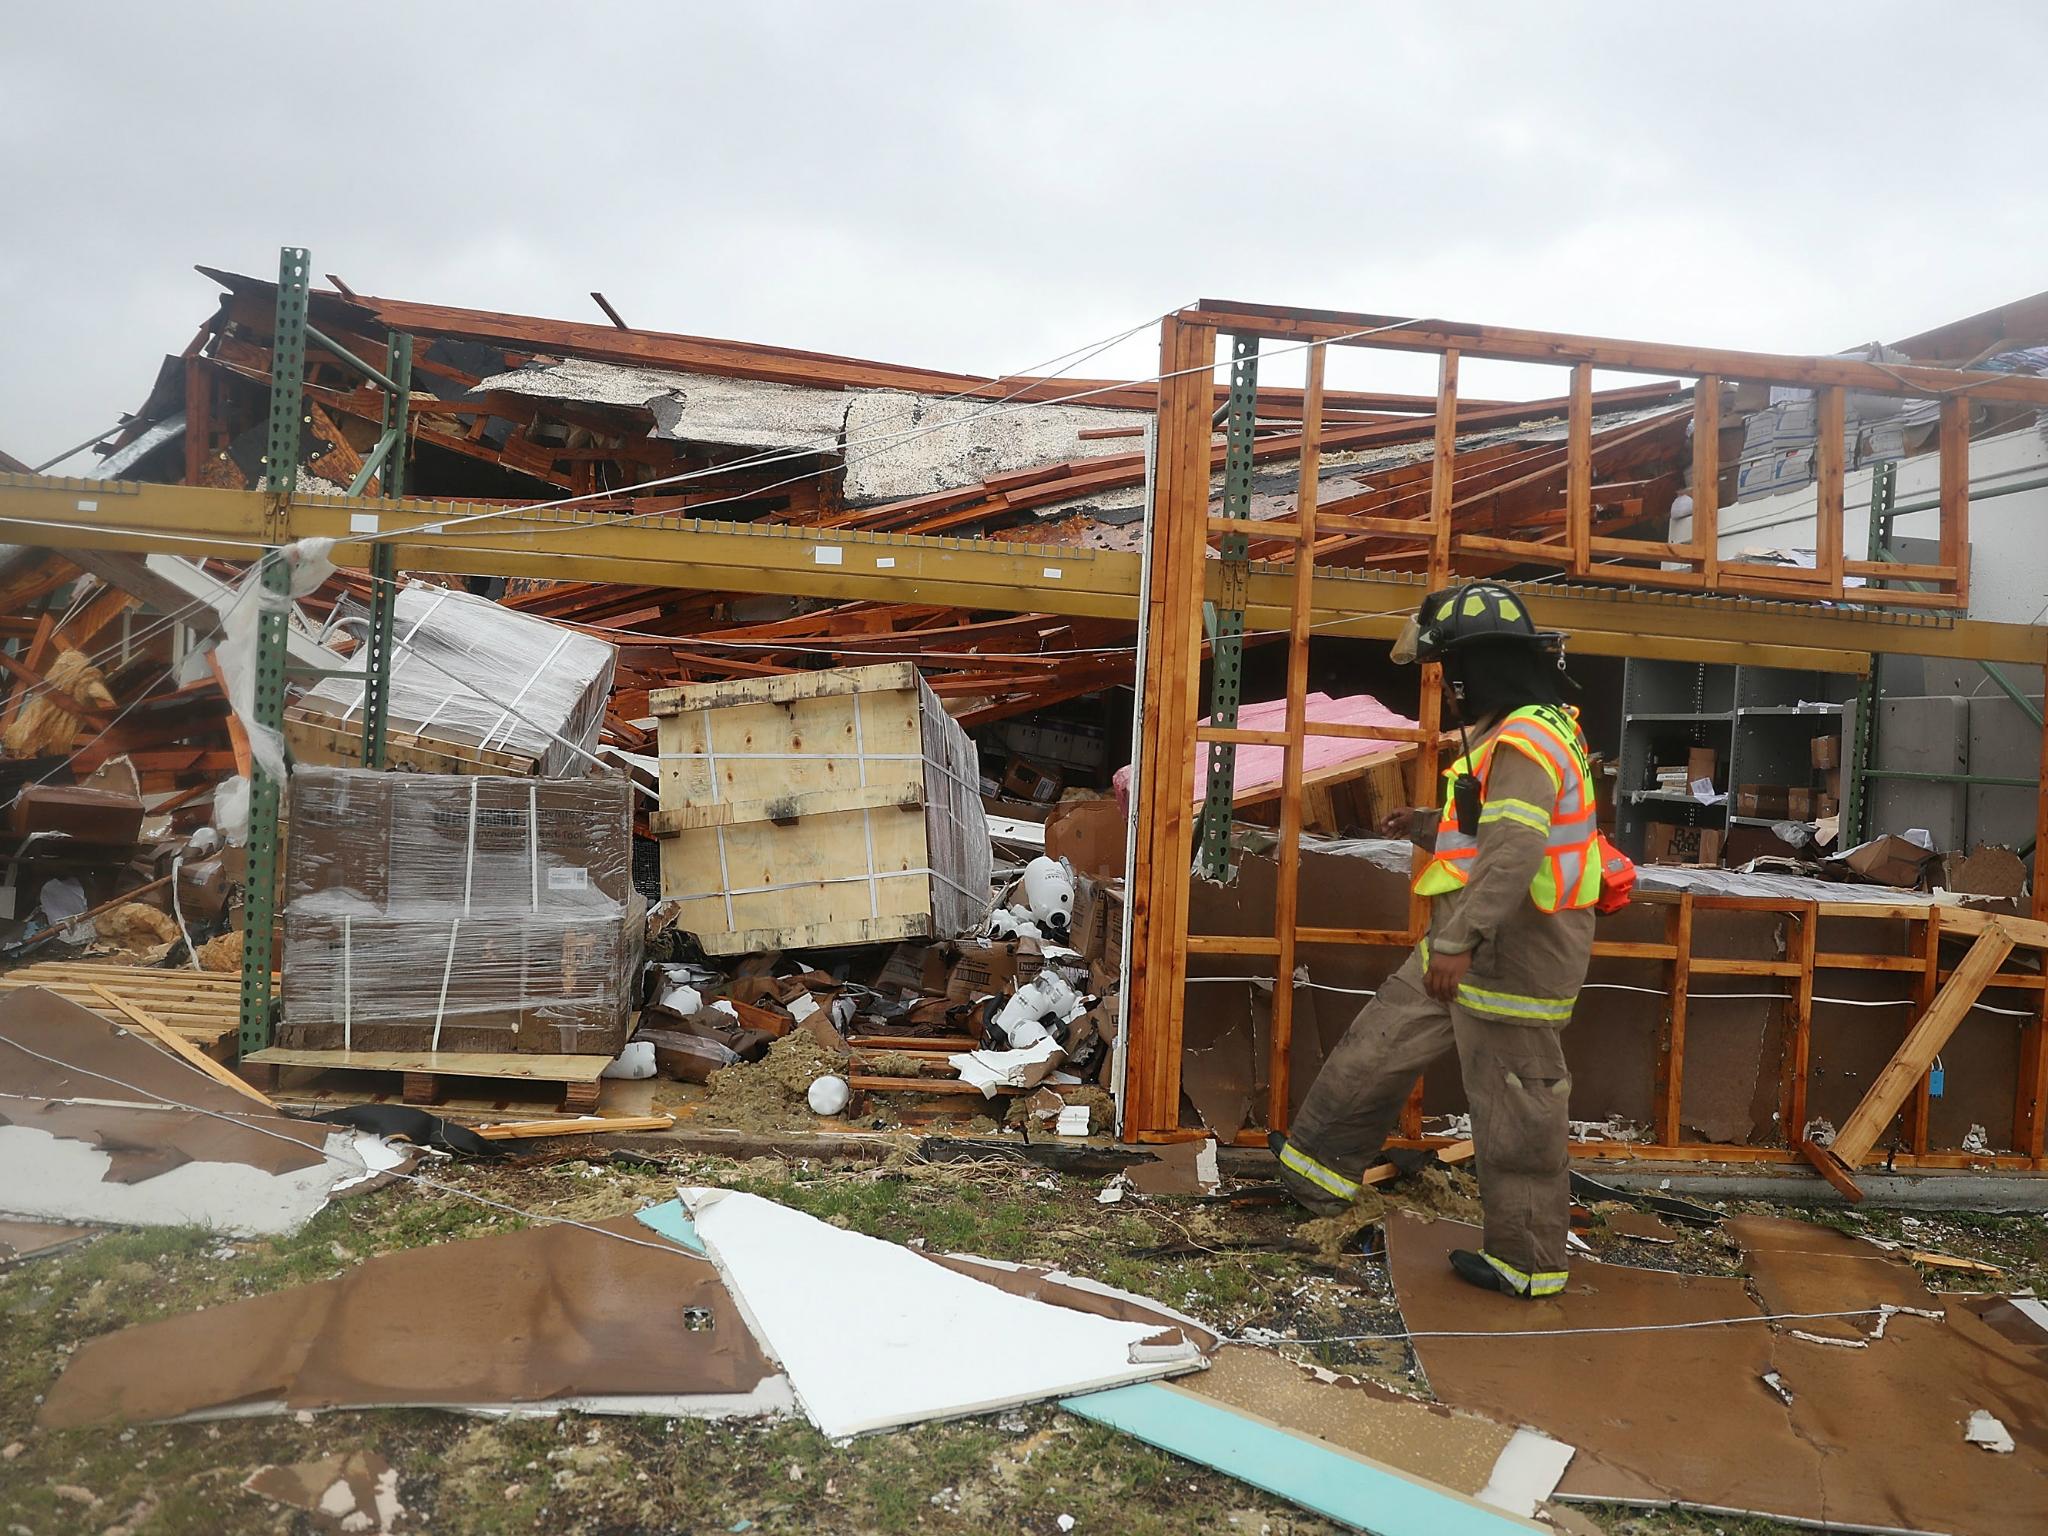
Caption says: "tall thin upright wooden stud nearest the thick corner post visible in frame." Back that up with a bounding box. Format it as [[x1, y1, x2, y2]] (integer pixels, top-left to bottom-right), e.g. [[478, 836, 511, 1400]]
[[1266, 346, 1327, 1133]]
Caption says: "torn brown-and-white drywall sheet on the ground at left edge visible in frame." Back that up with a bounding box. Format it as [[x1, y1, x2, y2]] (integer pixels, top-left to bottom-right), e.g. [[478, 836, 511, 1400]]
[[0, 987, 412, 1237]]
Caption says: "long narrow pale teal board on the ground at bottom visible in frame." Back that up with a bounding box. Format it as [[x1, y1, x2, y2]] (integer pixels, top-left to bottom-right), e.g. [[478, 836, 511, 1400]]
[[1061, 1382, 1548, 1536]]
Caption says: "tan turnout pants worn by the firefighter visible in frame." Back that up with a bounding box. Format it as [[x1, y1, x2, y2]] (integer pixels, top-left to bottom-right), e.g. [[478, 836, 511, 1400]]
[[1288, 954, 1571, 1274]]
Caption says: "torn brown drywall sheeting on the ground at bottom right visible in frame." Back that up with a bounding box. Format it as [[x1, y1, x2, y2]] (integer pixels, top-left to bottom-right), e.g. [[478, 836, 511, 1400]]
[[1386, 1212, 2048, 1536]]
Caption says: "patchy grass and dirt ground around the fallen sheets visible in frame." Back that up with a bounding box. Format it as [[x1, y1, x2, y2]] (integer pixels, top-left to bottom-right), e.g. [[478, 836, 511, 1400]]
[[0, 1141, 2048, 1536]]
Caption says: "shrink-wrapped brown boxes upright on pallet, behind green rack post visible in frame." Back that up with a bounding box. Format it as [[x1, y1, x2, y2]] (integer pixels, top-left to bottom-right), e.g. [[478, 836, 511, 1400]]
[[279, 768, 647, 1055]]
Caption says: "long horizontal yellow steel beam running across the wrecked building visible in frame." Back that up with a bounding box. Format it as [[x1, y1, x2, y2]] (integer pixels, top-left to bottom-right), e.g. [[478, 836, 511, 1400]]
[[0, 475, 2048, 674]]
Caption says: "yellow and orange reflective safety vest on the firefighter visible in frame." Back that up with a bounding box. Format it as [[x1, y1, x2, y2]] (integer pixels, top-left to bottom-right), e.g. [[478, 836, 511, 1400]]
[[1415, 705, 1599, 911]]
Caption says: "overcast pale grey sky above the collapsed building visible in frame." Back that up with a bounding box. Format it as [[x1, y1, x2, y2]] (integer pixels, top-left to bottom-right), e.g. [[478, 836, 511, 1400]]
[[0, 0, 2048, 463]]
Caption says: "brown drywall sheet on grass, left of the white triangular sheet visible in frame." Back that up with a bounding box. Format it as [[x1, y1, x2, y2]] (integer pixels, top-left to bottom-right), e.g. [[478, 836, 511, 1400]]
[[41, 1217, 795, 1427]]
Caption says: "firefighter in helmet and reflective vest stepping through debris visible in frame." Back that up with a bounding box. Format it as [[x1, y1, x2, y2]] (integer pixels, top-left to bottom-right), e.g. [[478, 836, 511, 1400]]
[[1272, 582, 1602, 1298]]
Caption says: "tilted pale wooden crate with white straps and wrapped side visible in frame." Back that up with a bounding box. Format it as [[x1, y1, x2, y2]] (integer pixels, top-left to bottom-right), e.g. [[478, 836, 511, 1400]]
[[647, 662, 989, 954]]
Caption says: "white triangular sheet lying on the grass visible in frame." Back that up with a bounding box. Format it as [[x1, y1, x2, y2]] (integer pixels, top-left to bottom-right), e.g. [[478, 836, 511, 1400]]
[[682, 1188, 1204, 1438]]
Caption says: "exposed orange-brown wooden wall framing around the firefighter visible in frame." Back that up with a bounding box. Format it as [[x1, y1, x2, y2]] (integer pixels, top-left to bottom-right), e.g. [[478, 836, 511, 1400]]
[[1122, 301, 2048, 1182]]
